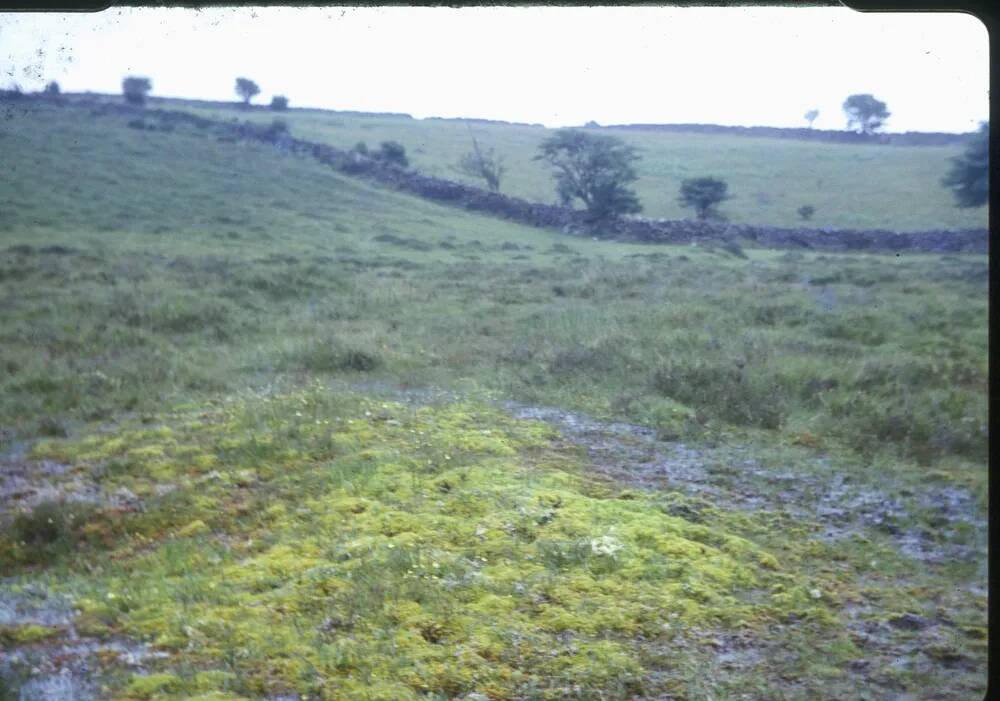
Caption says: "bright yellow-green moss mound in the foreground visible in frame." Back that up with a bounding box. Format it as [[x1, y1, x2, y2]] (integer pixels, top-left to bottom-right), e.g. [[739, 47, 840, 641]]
[[3, 388, 860, 699]]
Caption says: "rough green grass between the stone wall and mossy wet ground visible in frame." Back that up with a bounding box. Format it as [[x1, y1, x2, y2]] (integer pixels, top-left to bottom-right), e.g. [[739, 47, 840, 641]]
[[0, 102, 987, 476]]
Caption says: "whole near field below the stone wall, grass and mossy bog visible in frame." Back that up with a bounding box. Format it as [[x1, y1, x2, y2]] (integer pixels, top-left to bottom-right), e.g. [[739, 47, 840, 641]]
[[0, 103, 988, 701]]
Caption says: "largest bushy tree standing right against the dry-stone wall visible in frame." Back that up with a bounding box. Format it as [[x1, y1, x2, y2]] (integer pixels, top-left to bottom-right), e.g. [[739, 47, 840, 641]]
[[535, 129, 642, 219]]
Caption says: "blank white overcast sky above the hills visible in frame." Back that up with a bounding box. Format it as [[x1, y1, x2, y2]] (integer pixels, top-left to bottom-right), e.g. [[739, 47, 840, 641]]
[[0, 7, 989, 131]]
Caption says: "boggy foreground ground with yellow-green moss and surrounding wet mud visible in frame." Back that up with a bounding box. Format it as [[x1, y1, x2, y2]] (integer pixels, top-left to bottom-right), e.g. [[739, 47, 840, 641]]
[[0, 383, 986, 701]]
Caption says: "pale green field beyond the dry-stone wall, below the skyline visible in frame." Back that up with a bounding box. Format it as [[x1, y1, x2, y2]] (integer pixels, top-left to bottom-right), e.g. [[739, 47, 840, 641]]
[[174, 103, 987, 230]]
